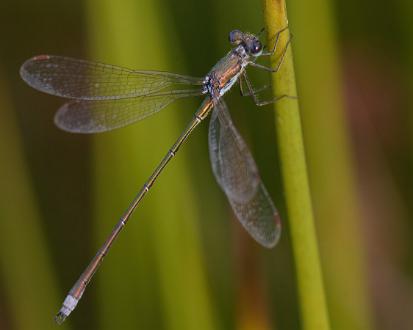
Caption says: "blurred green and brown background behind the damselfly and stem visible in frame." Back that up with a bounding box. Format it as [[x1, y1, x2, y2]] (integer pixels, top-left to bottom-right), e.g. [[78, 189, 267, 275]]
[[0, 0, 413, 330]]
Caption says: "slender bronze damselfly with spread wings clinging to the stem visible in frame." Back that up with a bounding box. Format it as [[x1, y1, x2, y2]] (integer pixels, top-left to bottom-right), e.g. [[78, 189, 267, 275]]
[[20, 28, 290, 323]]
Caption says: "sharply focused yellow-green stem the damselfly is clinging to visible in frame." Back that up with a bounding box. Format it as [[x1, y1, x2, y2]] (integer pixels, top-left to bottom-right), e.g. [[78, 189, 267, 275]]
[[263, 0, 329, 330]]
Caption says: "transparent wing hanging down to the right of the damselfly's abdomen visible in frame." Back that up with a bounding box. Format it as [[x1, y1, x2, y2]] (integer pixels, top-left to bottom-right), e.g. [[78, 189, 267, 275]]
[[209, 100, 281, 248]]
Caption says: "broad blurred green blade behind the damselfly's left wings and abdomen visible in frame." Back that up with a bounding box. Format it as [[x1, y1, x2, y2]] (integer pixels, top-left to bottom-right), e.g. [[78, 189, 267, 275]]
[[88, 0, 215, 329]]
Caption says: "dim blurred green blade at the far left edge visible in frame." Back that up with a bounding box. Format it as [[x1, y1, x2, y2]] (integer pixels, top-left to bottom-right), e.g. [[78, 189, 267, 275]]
[[0, 77, 68, 330]]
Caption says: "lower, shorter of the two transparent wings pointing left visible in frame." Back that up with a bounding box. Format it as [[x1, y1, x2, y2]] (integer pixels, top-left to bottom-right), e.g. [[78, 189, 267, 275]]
[[55, 91, 201, 133]]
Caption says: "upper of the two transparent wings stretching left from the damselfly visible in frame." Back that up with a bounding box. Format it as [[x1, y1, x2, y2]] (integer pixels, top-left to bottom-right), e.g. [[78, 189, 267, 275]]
[[20, 55, 203, 100]]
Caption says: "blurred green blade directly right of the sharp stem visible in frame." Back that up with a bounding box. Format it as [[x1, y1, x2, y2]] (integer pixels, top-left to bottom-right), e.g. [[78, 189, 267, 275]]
[[289, 0, 371, 330]]
